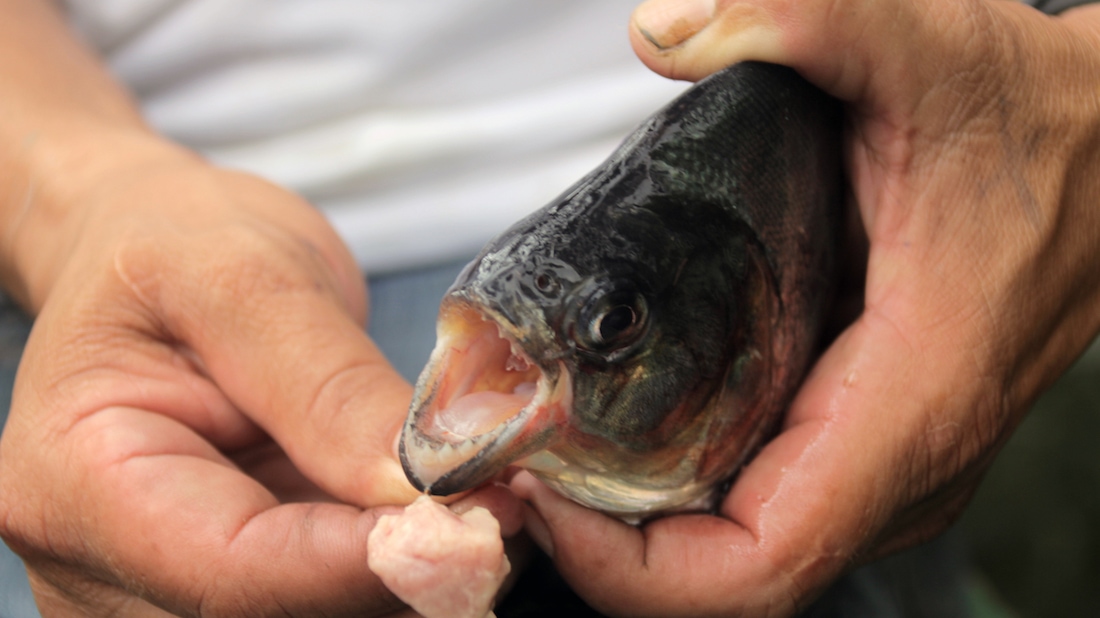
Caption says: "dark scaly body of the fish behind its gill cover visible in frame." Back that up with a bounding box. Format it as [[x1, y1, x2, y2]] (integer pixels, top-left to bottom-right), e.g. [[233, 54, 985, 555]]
[[642, 63, 843, 415]]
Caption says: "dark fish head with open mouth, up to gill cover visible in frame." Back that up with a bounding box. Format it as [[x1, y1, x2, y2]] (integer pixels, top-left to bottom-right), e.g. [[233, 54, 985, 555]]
[[399, 196, 777, 519]]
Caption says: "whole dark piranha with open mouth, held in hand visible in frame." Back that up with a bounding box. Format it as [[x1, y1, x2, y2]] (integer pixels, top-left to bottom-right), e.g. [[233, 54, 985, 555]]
[[399, 63, 843, 520]]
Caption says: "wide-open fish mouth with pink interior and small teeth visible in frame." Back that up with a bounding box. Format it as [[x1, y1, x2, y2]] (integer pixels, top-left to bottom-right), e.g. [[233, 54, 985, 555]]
[[398, 296, 573, 496]]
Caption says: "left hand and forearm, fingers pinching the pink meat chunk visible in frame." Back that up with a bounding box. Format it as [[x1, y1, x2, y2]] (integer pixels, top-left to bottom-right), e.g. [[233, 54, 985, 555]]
[[0, 0, 521, 617]]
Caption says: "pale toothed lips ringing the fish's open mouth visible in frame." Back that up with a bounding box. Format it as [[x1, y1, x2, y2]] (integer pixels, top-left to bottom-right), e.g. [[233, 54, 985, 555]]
[[398, 294, 573, 496]]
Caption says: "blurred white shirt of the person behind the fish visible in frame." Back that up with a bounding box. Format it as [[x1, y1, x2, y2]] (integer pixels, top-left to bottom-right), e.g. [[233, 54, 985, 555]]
[[64, 0, 684, 272]]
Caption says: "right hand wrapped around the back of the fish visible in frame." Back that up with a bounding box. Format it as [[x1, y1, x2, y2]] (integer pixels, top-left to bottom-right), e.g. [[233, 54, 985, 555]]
[[514, 0, 1100, 617]]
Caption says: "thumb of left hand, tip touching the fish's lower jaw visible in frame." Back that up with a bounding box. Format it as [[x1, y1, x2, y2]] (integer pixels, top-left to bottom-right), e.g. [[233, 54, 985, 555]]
[[101, 170, 416, 506]]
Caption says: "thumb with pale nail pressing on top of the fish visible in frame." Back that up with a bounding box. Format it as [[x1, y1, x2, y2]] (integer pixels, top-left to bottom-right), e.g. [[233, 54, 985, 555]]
[[630, 0, 983, 101]]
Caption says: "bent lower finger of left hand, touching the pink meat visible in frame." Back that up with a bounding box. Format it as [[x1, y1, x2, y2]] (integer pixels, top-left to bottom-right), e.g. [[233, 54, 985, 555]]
[[36, 408, 411, 616]]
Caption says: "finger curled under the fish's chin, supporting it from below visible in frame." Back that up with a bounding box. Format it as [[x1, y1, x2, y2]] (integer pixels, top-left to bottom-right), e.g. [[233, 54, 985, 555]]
[[513, 466, 793, 618]]
